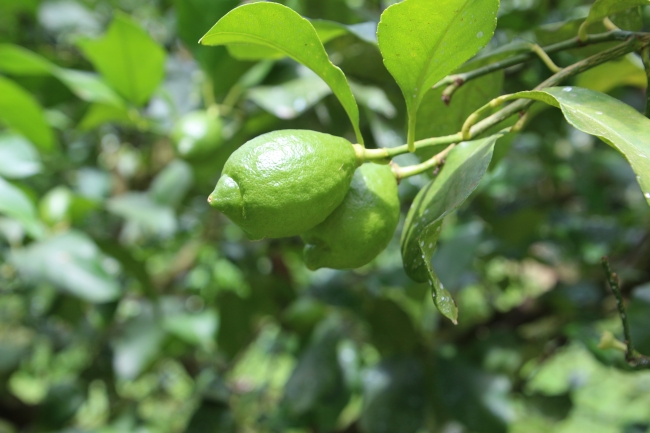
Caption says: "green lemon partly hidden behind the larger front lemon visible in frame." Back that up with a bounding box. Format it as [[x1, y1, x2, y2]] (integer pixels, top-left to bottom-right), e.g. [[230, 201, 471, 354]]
[[302, 164, 400, 269]]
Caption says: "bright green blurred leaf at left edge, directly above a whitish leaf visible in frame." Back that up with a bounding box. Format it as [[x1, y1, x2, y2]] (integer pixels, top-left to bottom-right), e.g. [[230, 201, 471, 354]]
[[0, 77, 54, 151]]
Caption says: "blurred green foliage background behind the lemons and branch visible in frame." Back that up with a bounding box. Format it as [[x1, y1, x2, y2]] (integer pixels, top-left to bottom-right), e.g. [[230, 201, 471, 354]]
[[0, 0, 650, 433]]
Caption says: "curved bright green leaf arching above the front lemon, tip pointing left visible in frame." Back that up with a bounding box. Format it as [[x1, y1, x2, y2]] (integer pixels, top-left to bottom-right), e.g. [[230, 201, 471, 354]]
[[200, 2, 363, 143]]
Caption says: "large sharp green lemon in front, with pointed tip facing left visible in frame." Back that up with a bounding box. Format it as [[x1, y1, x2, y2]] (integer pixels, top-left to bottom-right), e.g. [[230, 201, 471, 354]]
[[208, 130, 357, 239]]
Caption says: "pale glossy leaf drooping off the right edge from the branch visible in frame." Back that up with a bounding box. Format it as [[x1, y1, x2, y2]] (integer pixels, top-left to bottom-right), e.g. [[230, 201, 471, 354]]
[[517, 87, 650, 204]]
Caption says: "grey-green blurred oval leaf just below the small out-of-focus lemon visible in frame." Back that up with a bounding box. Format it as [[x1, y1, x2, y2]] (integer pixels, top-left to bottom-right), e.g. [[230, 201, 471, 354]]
[[149, 159, 194, 207]]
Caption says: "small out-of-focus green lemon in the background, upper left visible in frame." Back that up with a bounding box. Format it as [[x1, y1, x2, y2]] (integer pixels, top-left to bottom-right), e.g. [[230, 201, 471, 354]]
[[171, 110, 223, 159]]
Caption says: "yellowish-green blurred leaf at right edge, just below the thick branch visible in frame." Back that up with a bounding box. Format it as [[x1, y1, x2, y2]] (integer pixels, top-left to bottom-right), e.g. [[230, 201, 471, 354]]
[[576, 53, 648, 93]]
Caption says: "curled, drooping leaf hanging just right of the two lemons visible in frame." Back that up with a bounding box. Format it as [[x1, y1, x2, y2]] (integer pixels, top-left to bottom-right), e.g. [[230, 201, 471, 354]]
[[401, 135, 500, 323]]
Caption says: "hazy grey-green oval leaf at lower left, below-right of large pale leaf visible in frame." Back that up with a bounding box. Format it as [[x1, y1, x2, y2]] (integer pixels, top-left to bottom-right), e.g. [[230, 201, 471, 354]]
[[112, 312, 165, 380]]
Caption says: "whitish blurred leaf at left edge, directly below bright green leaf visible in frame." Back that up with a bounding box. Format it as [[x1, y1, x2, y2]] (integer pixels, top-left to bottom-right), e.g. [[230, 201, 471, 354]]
[[0, 133, 43, 179]]
